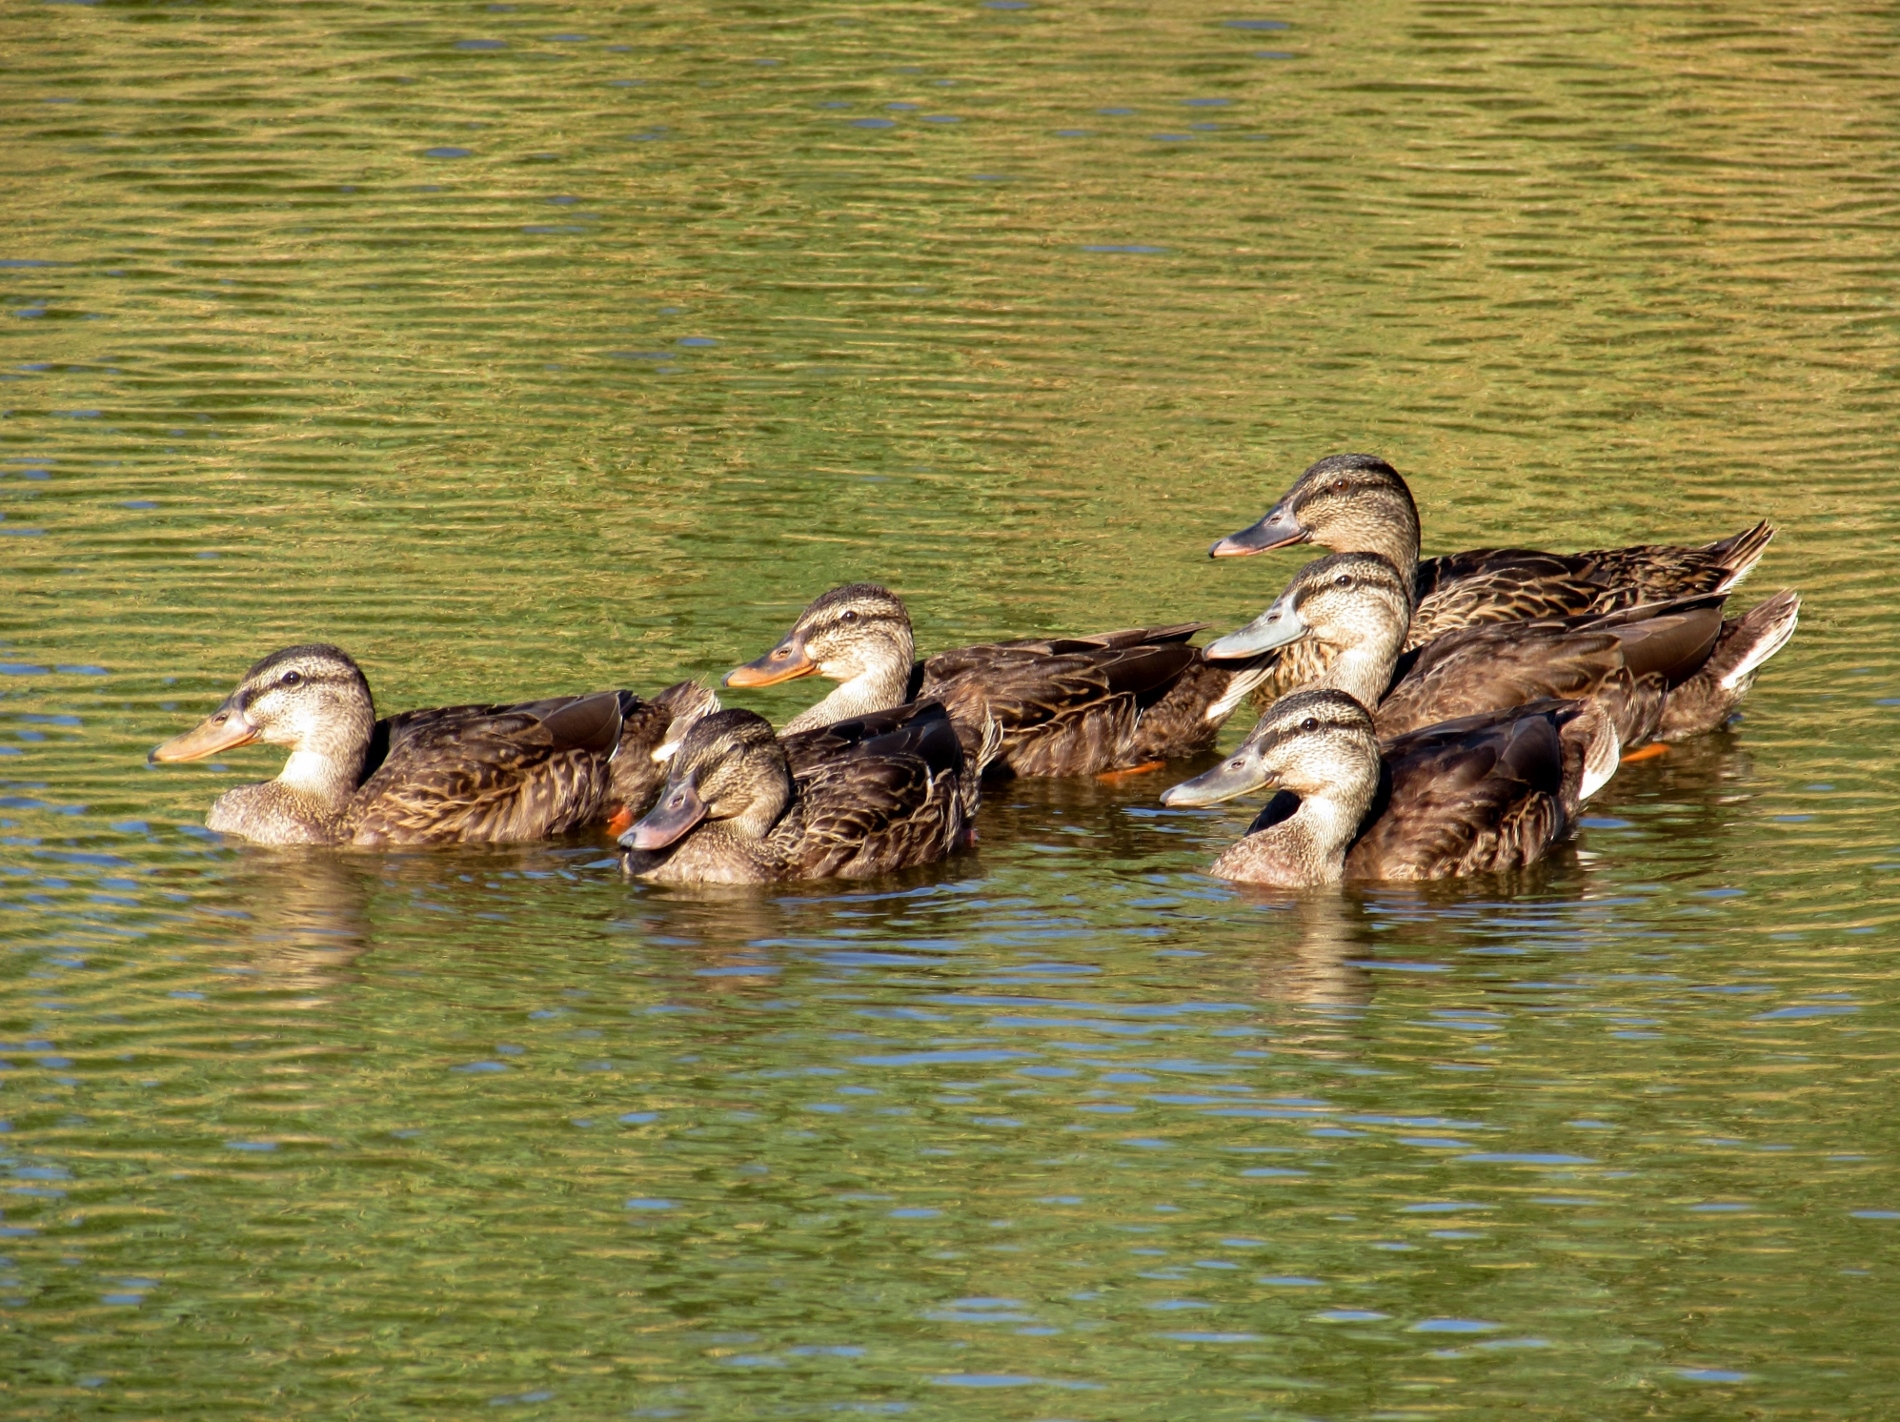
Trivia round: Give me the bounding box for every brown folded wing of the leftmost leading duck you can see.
[346,692,621,844]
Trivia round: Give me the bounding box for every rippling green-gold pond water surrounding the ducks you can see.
[0,0,1900,1422]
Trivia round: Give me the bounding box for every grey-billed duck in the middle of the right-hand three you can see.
[1207,553,1801,749]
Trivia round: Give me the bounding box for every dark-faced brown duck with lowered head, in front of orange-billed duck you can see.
[619,701,994,884]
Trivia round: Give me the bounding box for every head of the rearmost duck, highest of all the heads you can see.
[1207,454,1419,576]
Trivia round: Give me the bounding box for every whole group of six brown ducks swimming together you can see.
[152,454,1799,886]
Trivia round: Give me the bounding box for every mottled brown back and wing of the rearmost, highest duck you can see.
[1406,523,1775,646]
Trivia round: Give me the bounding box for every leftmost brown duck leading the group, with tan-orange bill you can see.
[150,643,718,846]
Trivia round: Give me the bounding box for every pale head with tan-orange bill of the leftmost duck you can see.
[150,643,376,795]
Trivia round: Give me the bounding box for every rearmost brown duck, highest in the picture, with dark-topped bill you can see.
[1208,454,1775,653]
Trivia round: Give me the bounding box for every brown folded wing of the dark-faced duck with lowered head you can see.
[768,701,973,878]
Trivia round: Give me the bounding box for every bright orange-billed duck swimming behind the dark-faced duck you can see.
[724,584,1264,776]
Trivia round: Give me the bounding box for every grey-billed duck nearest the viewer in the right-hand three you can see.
[1161,688,1621,888]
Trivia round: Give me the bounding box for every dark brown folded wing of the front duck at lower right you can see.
[1345,703,1577,878]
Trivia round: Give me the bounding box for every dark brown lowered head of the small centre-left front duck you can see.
[619,711,792,850]
